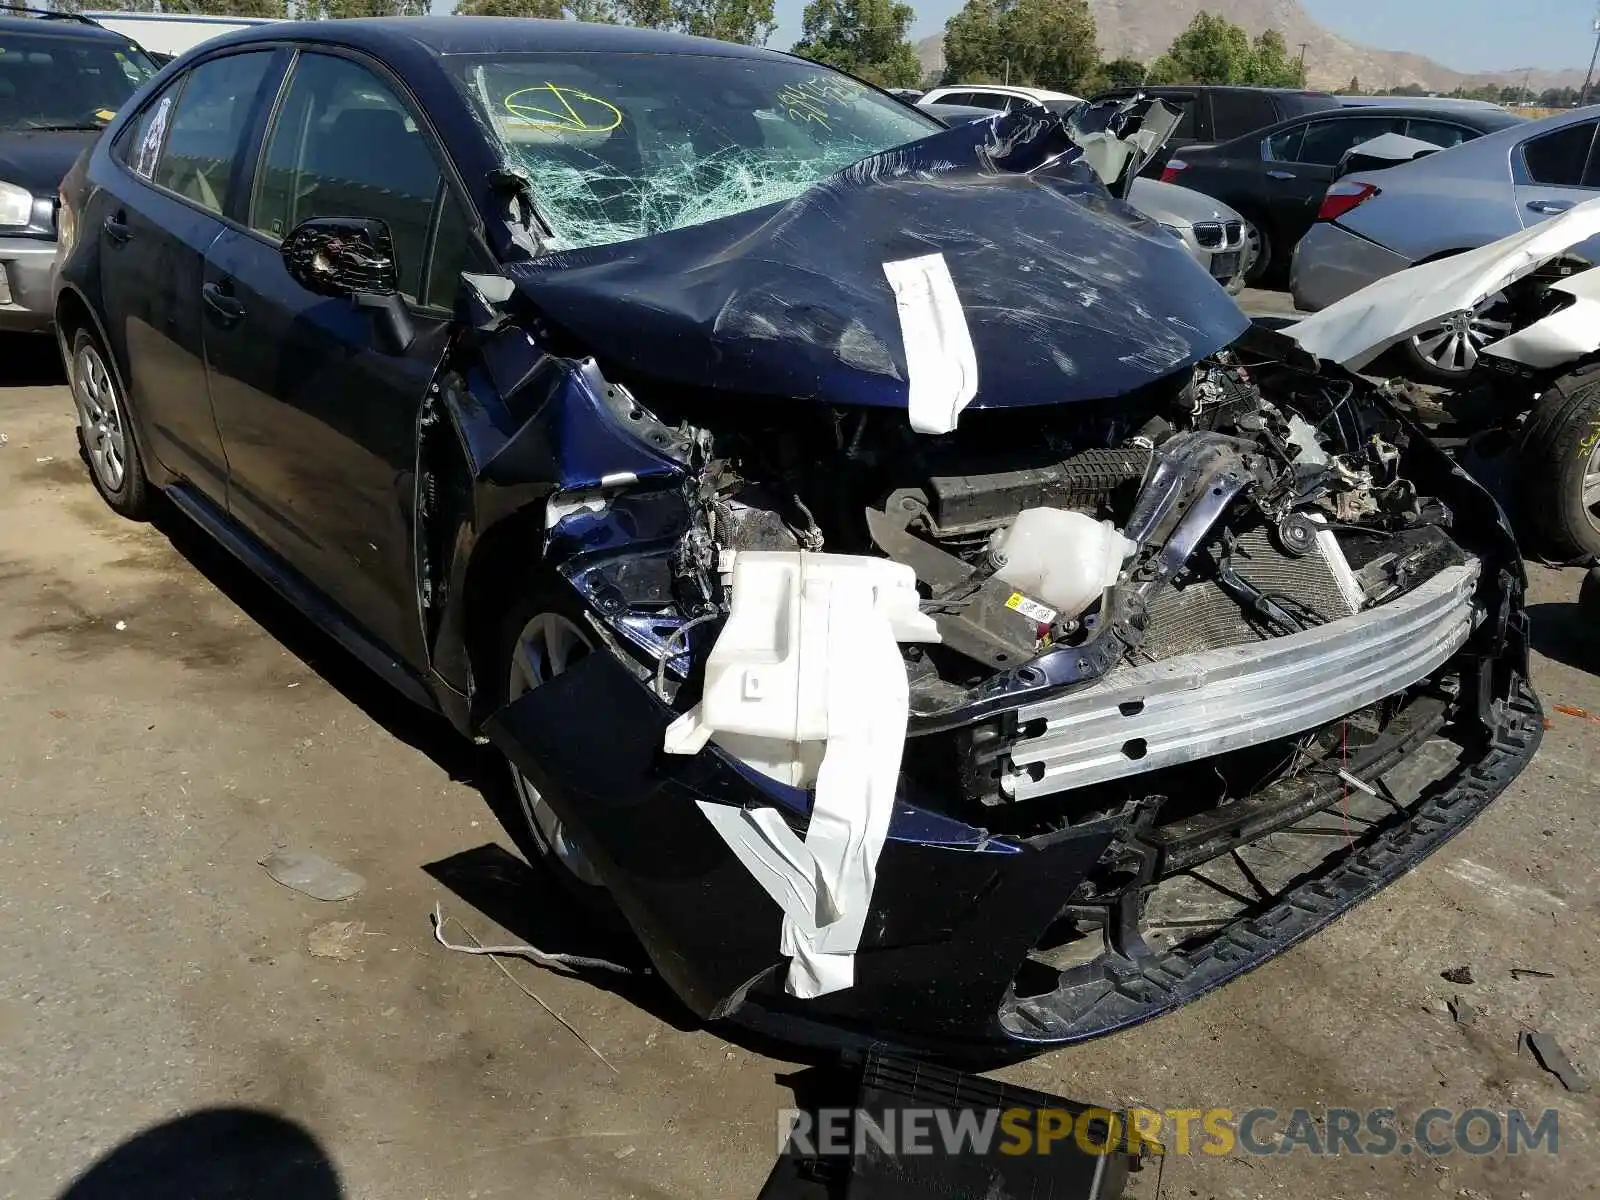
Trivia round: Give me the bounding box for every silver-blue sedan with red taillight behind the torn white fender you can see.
[1290,107,1600,384]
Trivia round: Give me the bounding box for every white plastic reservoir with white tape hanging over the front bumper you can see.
[664,552,939,998]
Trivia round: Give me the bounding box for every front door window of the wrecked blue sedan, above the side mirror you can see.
[250,54,442,299]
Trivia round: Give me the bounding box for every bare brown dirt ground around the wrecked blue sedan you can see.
[0,329,1600,1200]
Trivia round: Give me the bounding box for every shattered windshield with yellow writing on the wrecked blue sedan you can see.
[446,53,942,250]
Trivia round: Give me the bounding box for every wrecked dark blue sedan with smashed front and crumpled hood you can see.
[54,18,1542,1054]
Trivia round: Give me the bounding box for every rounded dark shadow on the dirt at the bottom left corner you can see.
[56,1107,344,1200]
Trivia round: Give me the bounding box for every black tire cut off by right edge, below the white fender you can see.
[1517,363,1600,563]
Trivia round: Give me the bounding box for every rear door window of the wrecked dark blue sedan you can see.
[150,50,274,213]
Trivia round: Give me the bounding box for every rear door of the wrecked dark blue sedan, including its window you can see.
[96,50,277,504]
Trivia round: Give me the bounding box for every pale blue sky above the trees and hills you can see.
[770,0,1597,70]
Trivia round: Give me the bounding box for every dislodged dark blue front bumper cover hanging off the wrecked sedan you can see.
[488,598,1542,1059]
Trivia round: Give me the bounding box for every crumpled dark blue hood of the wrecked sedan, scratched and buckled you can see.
[506,110,1248,408]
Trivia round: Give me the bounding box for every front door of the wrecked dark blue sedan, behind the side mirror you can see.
[202,51,464,667]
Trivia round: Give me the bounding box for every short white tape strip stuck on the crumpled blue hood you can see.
[883,254,978,434]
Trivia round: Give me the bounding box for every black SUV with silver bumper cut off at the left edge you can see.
[0,5,155,333]
